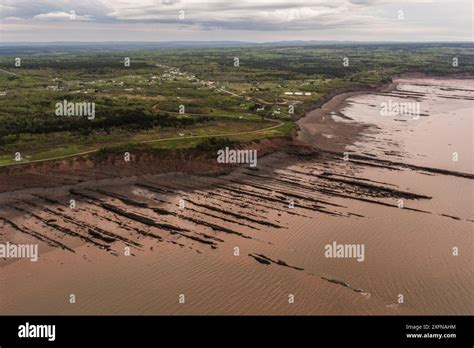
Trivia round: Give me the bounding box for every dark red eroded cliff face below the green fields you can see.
[0,138,292,192]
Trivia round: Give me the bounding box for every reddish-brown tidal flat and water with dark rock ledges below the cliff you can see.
[0,80,474,315]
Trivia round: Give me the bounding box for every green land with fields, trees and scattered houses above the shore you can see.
[0,44,474,165]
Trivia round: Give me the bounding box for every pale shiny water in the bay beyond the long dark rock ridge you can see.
[342,79,474,173]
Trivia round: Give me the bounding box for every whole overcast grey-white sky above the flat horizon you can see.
[0,0,474,42]
